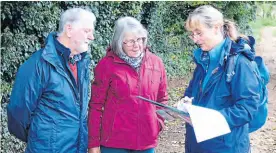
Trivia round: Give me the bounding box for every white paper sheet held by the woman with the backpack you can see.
[184,104,231,142]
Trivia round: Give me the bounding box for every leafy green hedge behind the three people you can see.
[0,1,257,153]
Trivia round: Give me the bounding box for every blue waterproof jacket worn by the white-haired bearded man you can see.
[7,33,90,153]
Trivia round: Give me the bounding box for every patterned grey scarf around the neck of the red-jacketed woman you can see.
[118,52,145,70]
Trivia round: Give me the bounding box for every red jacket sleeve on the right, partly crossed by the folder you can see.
[157,59,169,130]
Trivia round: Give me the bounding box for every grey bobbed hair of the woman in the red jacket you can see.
[111,17,148,55]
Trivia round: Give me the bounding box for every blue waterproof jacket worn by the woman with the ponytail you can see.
[184,38,261,153]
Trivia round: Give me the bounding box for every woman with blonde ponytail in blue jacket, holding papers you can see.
[184,5,260,153]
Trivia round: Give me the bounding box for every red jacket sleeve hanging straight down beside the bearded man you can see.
[88,59,109,148]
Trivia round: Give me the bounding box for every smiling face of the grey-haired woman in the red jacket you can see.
[123,32,144,57]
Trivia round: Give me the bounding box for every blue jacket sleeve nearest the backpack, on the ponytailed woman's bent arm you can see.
[220,56,260,128]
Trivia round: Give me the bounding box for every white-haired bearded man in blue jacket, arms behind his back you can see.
[7,8,96,153]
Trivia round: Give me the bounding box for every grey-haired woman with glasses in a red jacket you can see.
[88,17,168,153]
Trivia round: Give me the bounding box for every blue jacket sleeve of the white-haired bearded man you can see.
[7,60,42,142]
